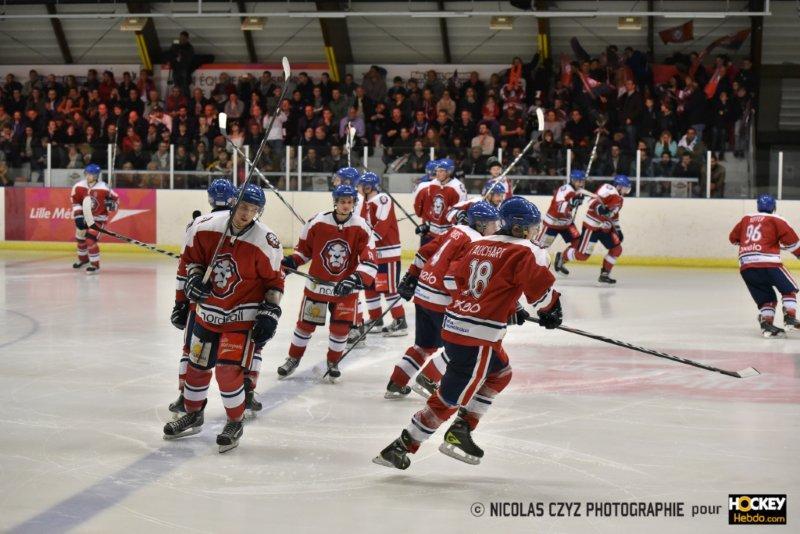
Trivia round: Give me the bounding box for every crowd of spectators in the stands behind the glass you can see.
[0,37,758,196]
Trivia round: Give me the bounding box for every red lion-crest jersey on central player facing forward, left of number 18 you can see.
[292,211,378,302]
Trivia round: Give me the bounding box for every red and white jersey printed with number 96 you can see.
[728,213,800,271]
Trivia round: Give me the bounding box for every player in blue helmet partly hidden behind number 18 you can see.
[384,201,500,399]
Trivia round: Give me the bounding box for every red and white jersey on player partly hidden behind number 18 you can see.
[408,224,483,313]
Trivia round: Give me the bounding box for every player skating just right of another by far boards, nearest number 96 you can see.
[554,174,631,284]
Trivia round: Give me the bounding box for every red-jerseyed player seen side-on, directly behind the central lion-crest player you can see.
[358,172,408,337]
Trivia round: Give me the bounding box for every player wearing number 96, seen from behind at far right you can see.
[729,195,800,338]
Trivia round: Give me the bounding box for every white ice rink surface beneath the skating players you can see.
[0,252,800,533]
